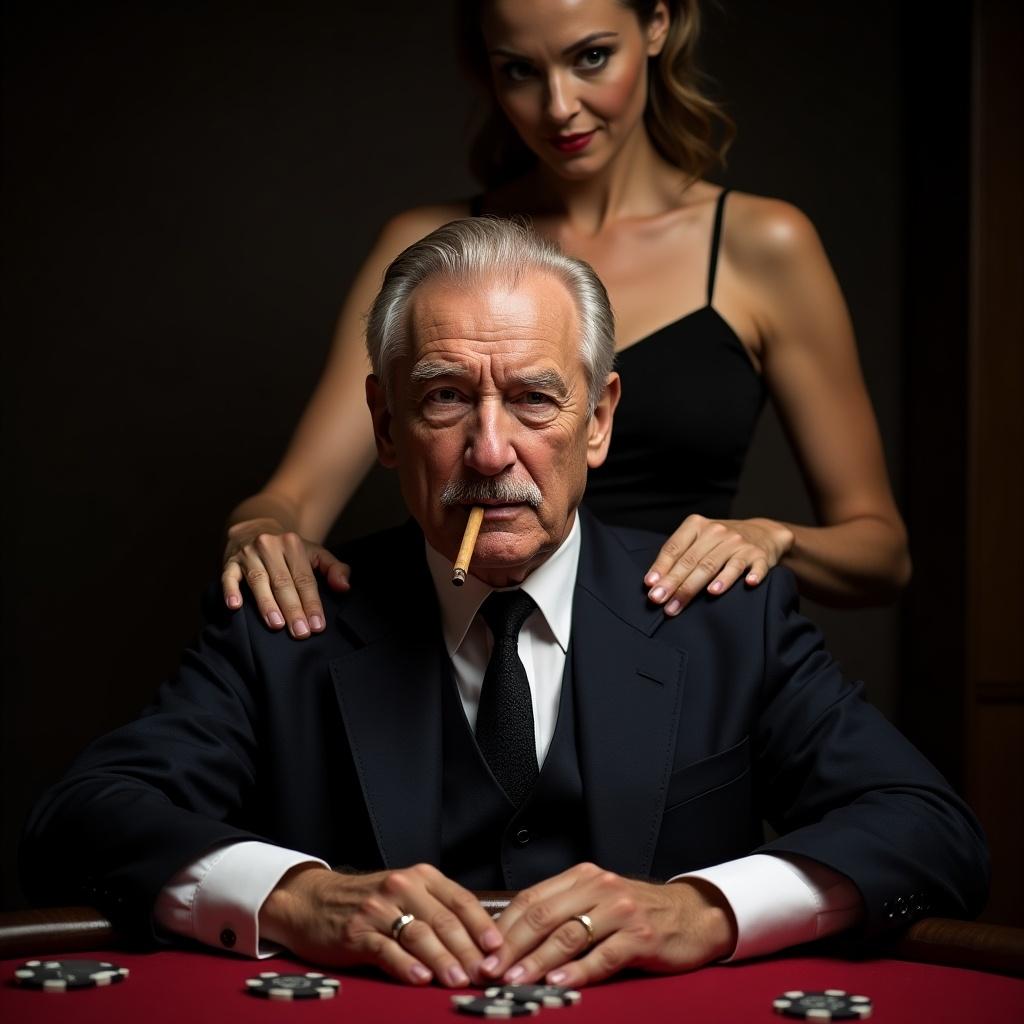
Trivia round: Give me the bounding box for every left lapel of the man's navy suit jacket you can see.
[331,529,444,868]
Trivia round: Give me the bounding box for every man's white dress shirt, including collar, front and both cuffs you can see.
[154,516,863,959]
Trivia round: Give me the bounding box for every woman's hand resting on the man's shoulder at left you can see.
[220,519,349,640]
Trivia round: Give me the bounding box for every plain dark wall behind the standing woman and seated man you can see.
[0,0,969,906]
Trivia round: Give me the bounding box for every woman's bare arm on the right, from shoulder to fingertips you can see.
[646,195,910,613]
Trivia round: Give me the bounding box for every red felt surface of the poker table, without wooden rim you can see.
[0,937,1024,1024]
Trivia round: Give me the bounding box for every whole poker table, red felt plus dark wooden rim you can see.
[0,909,1024,1024]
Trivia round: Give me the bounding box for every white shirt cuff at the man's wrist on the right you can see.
[669,853,863,962]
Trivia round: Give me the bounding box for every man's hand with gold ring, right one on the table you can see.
[483,864,736,987]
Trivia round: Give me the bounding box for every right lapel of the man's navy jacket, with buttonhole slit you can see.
[572,516,686,876]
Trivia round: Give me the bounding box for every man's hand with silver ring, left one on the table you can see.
[259,864,502,988]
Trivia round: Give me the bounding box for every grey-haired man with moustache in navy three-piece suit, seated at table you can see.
[24,220,986,986]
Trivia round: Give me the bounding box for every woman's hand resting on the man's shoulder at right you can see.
[644,515,793,615]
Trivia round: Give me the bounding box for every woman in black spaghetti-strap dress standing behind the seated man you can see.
[223,0,909,638]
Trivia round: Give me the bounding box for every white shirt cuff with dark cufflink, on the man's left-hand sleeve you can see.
[153,841,328,958]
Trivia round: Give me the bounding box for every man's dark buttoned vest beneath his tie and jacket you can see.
[440,645,589,890]
